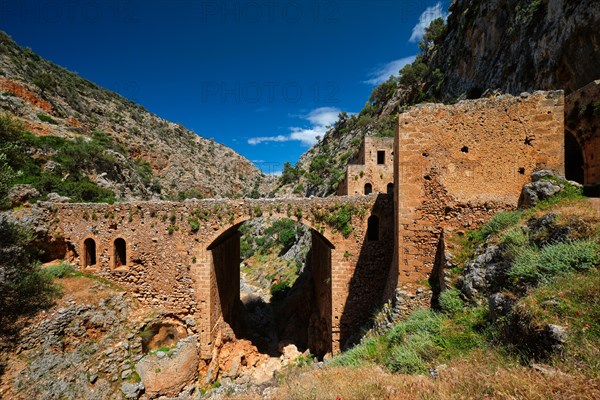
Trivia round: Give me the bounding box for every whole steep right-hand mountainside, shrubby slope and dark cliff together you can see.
[273,0,600,196]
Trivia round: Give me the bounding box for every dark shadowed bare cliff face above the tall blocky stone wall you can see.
[432,0,600,98]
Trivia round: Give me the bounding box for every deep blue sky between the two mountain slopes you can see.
[0,0,448,172]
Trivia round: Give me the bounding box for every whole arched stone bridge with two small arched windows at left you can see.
[48,194,397,359]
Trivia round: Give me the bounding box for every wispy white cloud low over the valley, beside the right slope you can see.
[248,107,341,146]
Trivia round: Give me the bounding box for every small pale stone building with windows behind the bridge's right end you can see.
[337,136,394,196]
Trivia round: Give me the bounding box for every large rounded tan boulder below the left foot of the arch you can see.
[135,336,199,398]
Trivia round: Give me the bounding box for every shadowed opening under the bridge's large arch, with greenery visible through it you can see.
[208,217,333,356]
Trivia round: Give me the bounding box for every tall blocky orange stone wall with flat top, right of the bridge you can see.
[394,92,564,289]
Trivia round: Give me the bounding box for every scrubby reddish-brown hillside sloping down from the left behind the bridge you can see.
[0,32,263,200]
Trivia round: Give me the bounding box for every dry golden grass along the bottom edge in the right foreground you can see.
[258,351,600,400]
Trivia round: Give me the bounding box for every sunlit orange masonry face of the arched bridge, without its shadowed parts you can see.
[46,196,393,358]
